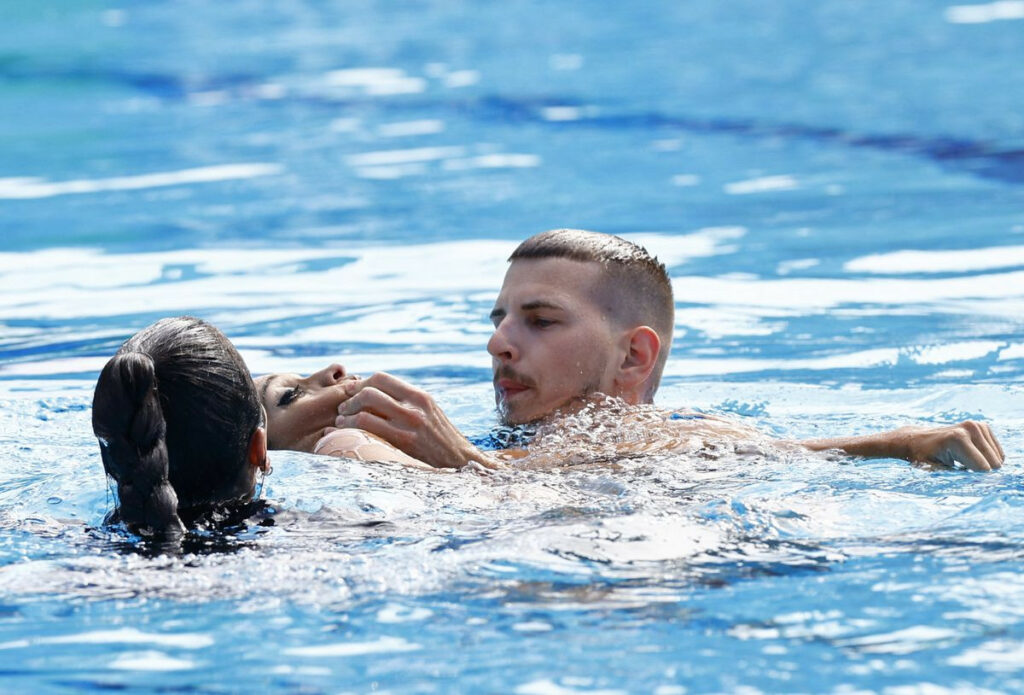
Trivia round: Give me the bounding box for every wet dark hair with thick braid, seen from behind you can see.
[92,316,261,539]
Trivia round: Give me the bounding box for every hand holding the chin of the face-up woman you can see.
[335,372,498,468]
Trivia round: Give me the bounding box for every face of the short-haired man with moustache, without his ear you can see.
[487,258,626,424]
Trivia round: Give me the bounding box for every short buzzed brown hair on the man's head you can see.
[509,229,676,400]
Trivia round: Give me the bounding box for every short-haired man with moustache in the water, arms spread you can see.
[336,229,1005,471]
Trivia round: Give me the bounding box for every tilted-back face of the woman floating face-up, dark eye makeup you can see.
[256,364,355,451]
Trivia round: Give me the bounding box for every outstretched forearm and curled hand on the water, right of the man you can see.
[800,420,1006,471]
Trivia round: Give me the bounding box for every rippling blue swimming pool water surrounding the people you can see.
[0,0,1024,695]
